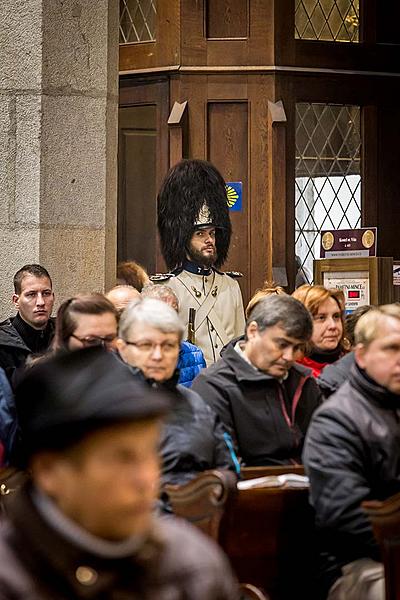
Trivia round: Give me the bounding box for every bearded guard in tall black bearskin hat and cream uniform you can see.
[150,160,245,365]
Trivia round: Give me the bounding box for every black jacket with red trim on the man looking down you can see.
[192,344,321,466]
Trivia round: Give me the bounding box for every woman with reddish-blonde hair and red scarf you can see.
[292,284,346,377]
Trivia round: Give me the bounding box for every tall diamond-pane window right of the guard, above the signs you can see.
[295,102,361,283]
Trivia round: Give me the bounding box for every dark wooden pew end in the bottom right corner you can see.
[362,493,400,600]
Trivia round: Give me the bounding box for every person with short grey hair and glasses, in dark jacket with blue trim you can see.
[117,298,237,494]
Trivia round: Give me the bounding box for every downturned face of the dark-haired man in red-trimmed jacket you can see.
[245,321,304,379]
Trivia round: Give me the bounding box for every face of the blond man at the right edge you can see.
[355,317,400,395]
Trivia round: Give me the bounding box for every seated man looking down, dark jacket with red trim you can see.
[192,294,320,466]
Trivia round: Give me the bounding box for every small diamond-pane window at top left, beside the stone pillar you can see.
[119,0,157,44]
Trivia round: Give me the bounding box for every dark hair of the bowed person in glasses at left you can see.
[53,293,118,350]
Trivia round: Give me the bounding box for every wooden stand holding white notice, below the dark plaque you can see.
[314,257,393,313]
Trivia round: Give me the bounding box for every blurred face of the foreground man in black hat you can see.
[32,420,160,541]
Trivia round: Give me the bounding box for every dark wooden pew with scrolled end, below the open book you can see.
[166,467,316,600]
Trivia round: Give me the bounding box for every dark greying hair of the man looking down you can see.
[246,294,313,342]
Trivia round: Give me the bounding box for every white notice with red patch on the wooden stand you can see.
[324,271,369,313]
